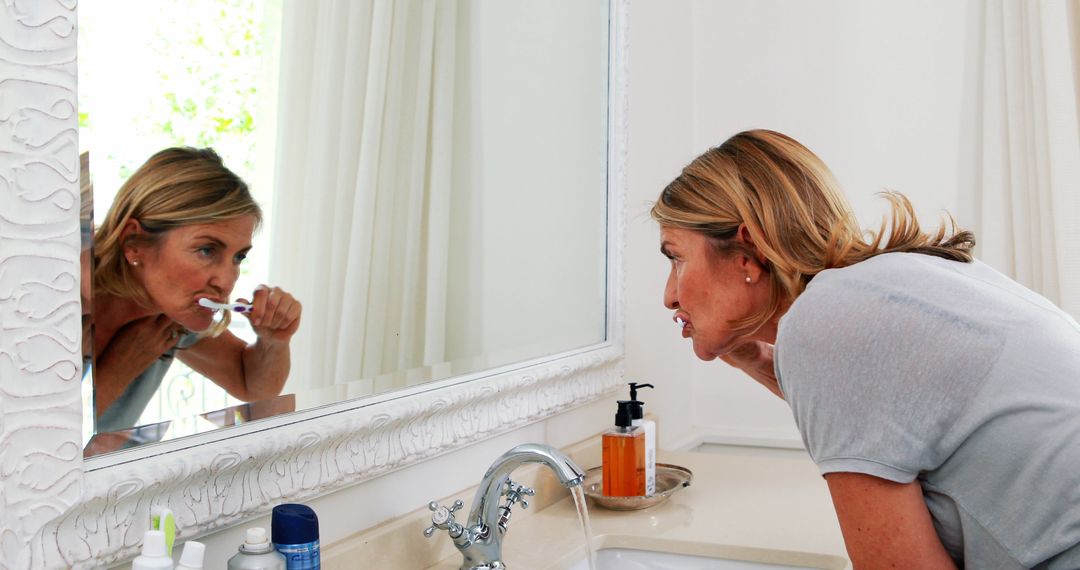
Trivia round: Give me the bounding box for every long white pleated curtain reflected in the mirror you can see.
[270,0,457,392]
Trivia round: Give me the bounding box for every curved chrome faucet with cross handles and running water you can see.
[423,444,585,570]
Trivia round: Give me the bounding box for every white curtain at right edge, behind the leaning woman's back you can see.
[959,0,1080,318]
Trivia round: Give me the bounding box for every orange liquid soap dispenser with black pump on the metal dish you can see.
[600,399,645,497]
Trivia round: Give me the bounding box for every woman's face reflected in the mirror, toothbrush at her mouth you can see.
[135,216,256,330]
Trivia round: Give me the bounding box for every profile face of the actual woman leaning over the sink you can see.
[660,228,760,361]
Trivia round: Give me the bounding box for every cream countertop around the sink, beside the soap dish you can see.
[431,451,850,570]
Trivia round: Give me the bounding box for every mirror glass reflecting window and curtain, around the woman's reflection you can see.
[78,0,611,456]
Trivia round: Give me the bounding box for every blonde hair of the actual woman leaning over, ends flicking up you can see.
[651,130,975,336]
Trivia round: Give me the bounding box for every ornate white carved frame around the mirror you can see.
[0,0,629,569]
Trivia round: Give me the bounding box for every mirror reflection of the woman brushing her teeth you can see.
[93,148,301,433]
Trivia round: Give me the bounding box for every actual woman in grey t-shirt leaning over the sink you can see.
[652,131,1080,569]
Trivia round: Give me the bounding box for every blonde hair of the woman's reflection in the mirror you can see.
[94,147,262,335]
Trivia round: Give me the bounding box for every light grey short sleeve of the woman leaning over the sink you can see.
[775,273,1003,483]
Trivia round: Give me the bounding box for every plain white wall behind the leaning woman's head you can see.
[626,0,970,447]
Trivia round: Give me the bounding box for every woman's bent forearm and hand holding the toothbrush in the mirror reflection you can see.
[176,287,301,402]
